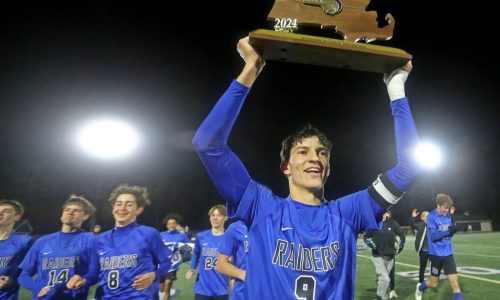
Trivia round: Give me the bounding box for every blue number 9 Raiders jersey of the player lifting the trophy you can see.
[193,81,421,300]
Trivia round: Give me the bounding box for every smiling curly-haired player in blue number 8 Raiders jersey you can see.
[95,184,170,300]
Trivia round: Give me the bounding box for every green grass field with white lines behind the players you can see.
[20,232,500,300]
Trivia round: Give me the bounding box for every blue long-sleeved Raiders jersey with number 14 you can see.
[19,231,98,299]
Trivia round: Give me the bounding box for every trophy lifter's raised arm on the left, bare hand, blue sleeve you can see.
[193,37,265,214]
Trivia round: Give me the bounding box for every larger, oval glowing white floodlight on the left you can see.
[77,119,139,160]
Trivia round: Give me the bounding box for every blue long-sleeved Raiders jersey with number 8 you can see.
[95,222,170,300]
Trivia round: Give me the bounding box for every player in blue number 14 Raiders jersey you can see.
[19,195,98,299]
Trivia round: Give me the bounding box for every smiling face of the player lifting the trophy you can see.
[281,136,330,193]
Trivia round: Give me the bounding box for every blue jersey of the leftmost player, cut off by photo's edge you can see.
[0,233,33,300]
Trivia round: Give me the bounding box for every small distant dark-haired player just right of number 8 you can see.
[160,214,190,300]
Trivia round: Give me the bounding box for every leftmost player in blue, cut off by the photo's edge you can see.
[0,199,33,300]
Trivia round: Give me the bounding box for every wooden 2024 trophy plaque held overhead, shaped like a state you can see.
[250,0,412,73]
